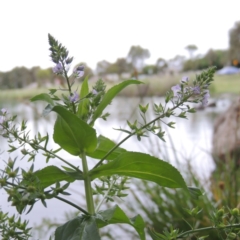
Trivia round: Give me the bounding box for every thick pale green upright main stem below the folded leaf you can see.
[80,152,95,215]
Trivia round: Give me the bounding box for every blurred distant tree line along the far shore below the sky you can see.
[0,22,240,89]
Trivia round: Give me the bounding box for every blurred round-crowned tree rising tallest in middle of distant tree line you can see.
[127,46,150,71]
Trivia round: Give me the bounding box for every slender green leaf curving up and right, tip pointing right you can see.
[90,80,142,125]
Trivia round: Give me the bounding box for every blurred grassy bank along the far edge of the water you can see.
[0,74,240,101]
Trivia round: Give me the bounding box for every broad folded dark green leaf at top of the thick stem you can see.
[52,106,97,156]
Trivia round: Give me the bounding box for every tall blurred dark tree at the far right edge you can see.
[229,22,240,66]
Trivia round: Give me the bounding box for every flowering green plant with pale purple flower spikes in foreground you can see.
[0,34,238,240]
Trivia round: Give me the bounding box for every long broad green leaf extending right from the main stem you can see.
[89,152,187,189]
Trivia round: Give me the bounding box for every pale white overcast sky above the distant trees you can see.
[0,0,240,72]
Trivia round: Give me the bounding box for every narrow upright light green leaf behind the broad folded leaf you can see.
[77,77,89,119]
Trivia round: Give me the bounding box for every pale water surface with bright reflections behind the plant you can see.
[0,97,230,239]
